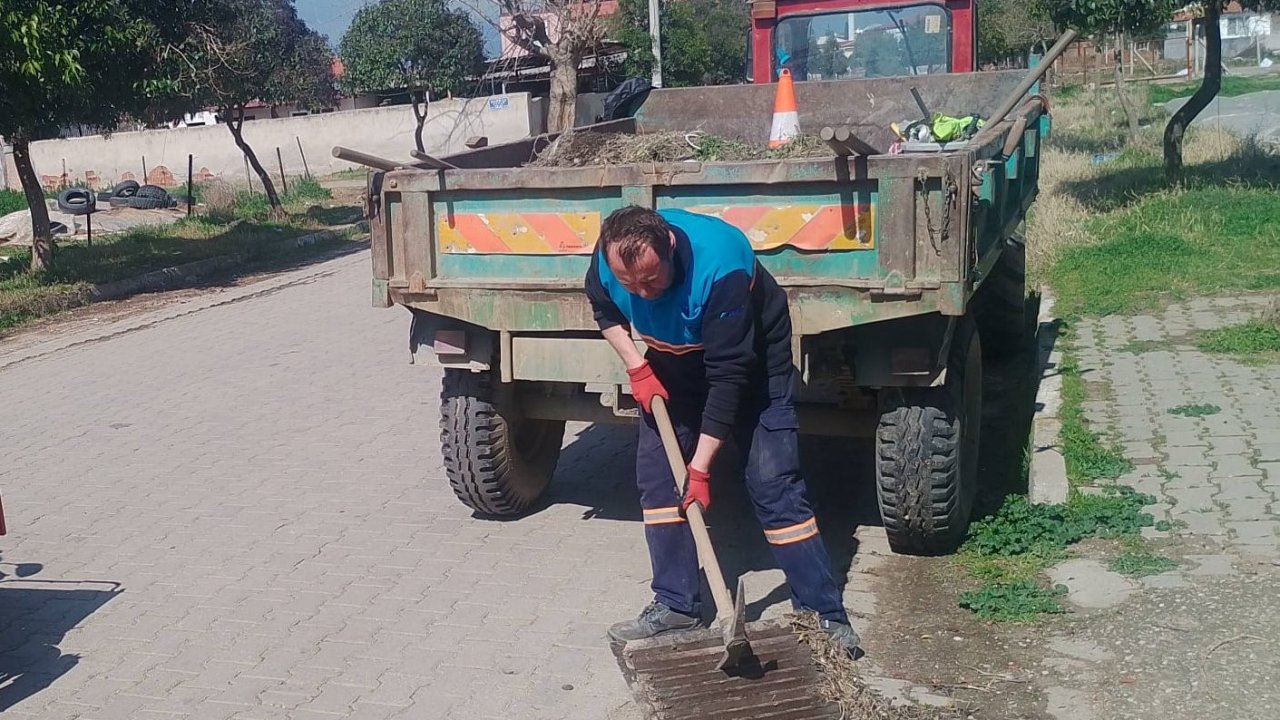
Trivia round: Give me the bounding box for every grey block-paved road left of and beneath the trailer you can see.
[0,255,883,720]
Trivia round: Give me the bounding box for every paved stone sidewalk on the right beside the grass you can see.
[1078,296,1280,562]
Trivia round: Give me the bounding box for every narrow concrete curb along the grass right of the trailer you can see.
[1028,287,1069,505]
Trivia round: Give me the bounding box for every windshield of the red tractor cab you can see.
[773,4,951,79]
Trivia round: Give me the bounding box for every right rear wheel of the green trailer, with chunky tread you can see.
[876,316,982,555]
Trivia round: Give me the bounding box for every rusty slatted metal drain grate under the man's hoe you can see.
[613,620,840,720]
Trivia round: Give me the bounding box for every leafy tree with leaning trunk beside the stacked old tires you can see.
[173,0,337,215]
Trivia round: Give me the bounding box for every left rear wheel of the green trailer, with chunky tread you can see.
[440,369,564,518]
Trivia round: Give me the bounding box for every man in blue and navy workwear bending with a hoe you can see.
[586,206,859,653]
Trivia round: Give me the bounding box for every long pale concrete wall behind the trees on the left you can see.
[8,94,547,187]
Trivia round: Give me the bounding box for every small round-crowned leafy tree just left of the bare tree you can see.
[338,0,484,151]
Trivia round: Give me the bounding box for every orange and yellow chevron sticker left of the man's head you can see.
[435,213,600,255]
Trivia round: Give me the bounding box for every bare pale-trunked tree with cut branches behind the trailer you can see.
[466,0,609,132]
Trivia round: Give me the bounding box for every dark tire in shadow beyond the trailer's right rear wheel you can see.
[974,233,1029,360]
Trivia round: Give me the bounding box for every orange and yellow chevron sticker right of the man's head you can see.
[689,205,876,250]
